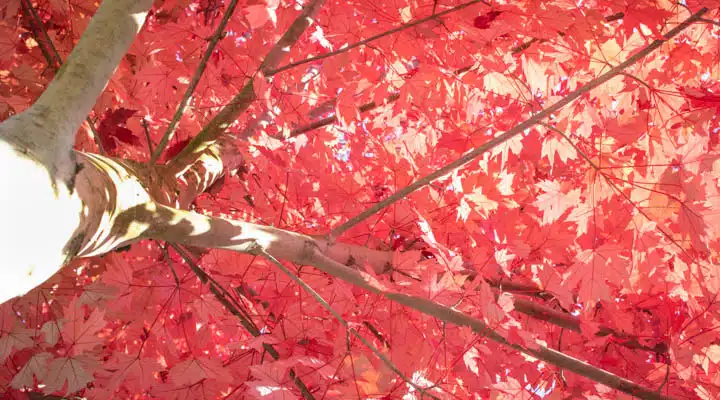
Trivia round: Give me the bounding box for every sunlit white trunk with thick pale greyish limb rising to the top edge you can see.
[0,0,152,303]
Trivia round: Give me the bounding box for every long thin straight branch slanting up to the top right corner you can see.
[330,8,708,238]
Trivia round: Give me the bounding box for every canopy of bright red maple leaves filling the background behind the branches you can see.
[0,0,720,399]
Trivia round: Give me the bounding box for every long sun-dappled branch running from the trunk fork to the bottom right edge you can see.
[142,205,667,399]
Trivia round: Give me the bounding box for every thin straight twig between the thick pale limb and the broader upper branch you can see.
[148,0,243,165]
